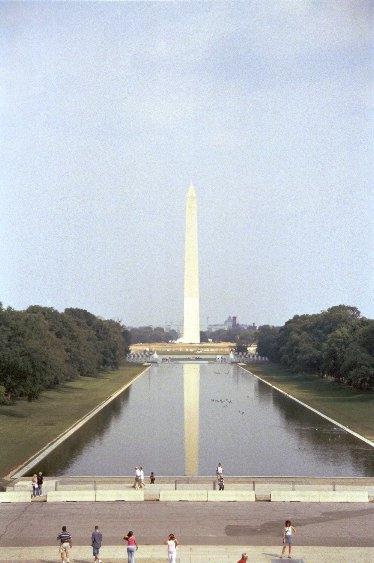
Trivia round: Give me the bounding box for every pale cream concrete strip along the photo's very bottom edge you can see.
[0,545,374,563]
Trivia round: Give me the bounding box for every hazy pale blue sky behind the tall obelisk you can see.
[0,0,374,326]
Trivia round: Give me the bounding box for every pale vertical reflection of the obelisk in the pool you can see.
[183,364,200,475]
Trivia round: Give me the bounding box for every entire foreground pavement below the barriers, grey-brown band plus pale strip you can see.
[0,502,374,563]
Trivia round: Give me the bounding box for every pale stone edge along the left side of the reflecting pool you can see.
[4,365,151,479]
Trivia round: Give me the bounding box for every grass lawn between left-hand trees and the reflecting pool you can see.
[0,365,144,476]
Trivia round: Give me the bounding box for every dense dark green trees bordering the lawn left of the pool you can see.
[0,304,130,403]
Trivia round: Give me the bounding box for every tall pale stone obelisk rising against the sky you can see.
[182,184,200,344]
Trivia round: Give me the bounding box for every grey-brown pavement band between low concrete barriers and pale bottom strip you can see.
[0,502,374,548]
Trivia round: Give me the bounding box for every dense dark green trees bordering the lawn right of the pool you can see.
[257,305,374,390]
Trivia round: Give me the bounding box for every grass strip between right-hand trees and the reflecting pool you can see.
[243,364,374,441]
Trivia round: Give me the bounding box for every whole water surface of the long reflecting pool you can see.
[32,362,374,477]
